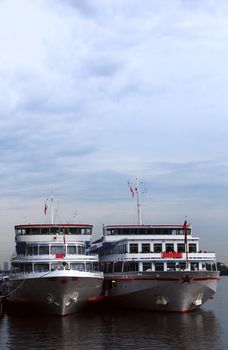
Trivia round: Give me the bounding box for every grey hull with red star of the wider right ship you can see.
[103,271,219,312]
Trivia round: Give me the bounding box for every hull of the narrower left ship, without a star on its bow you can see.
[7,271,103,316]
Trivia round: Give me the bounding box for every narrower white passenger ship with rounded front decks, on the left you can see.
[7,212,103,316]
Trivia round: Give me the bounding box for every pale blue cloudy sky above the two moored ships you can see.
[0,0,228,263]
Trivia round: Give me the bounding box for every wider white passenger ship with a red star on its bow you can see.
[92,178,219,312]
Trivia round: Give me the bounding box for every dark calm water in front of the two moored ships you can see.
[0,277,228,350]
